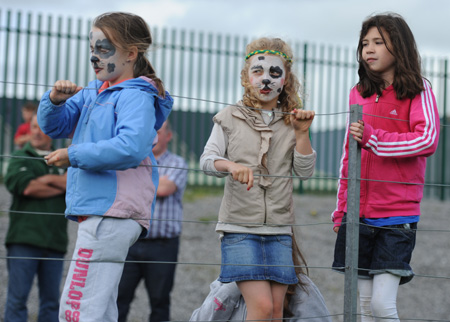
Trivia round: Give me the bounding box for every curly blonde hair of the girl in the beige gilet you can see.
[241,37,303,124]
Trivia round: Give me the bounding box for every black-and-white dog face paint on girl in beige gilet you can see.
[248,54,286,103]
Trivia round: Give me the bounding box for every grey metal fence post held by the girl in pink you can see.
[344,105,362,322]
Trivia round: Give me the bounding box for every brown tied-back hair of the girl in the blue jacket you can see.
[93,12,165,97]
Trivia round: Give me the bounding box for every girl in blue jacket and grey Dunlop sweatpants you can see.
[38,12,173,322]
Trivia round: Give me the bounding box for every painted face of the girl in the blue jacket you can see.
[89,27,133,85]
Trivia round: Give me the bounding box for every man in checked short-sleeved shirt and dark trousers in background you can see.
[117,121,187,322]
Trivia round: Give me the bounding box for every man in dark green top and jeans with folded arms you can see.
[4,114,68,322]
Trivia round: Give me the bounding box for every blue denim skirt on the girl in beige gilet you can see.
[219,233,298,284]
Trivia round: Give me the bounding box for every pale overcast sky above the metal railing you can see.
[0,0,450,57]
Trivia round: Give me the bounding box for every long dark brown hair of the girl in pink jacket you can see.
[357,13,424,100]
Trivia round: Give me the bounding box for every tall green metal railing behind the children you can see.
[0,9,450,200]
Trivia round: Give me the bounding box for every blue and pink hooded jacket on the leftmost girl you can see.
[38,77,173,229]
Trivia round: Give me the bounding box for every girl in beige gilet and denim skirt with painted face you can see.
[200,38,316,321]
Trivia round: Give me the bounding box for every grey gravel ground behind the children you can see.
[0,186,450,322]
